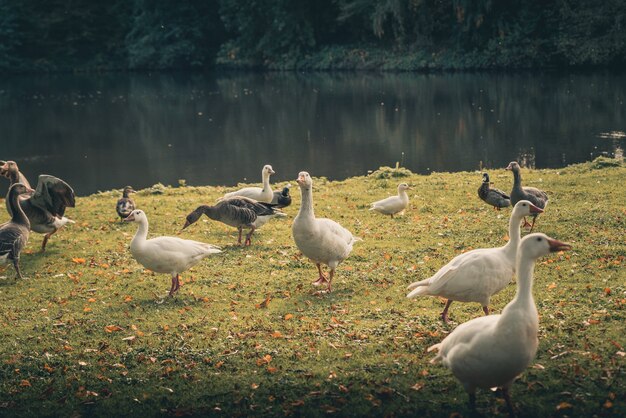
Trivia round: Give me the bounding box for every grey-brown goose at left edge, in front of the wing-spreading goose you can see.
[0,183,34,279]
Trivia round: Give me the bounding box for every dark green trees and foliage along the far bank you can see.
[0,0,626,71]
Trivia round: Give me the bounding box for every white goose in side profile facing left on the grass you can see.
[124,209,222,297]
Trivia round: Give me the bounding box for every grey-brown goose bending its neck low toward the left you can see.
[183,196,287,246]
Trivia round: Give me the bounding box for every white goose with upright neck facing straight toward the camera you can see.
[292,171,362,292]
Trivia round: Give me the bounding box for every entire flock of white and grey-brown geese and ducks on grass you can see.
[0,161,571,412]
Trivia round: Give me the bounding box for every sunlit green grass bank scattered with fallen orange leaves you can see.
[0,161,626,417]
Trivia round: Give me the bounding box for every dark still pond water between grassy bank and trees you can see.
[0,73,626,195]
